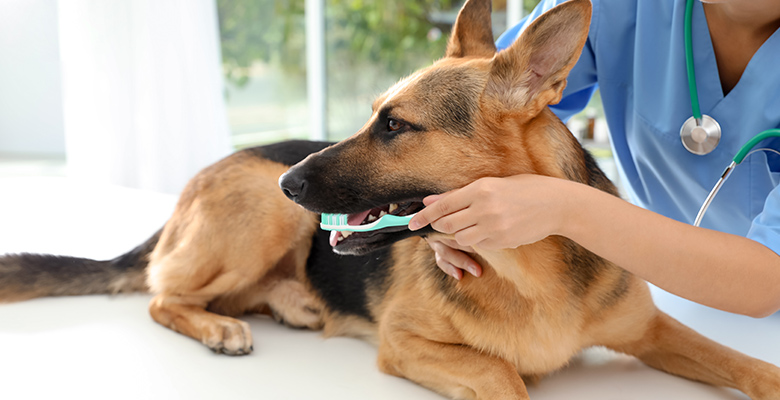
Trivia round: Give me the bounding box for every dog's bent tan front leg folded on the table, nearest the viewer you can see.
[378,330,529,400]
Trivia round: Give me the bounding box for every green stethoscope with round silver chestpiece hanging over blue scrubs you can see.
[680,0,780,226]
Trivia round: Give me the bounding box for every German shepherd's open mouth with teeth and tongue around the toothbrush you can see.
[330,201,425,247]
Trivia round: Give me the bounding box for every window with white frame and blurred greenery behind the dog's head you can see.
[217,0,538,148]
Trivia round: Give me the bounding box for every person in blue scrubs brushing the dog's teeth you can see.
[409,0,780,317]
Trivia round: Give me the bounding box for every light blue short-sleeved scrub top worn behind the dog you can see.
[497,0,780,254]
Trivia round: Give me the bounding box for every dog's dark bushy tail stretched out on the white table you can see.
[0,230,162,303]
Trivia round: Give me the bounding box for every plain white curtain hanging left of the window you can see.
[58,0,230,193]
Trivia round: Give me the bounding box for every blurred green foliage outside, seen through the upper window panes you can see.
[217,0,538,87]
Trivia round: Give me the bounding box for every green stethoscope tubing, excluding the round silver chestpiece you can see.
[684,0,780,226]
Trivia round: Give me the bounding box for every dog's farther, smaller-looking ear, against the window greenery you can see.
[445,0,496,58]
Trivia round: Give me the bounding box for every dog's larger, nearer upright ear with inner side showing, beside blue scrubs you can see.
[485,0,591,116]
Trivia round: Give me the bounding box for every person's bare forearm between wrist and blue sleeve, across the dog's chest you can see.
[559,183,780,316]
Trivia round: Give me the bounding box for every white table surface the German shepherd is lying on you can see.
[0,177,780,400]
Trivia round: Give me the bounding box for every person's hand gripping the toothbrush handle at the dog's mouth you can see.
[409,175,573,250]
